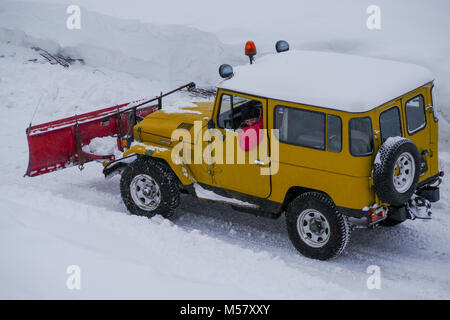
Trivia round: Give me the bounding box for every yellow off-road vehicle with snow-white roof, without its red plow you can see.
[27,41,443,260]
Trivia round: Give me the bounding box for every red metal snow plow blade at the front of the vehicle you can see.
[25,82,195,177]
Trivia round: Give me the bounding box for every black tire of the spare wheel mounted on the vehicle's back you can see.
[373,138,421,206]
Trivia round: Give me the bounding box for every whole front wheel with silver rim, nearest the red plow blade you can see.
[120,158,180,218]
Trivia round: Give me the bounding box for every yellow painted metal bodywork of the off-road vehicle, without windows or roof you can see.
[124,82,438,210]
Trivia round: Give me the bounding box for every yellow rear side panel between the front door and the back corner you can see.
[268,100,375,209]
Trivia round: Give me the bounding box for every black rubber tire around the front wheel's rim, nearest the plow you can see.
[120,158,180,218]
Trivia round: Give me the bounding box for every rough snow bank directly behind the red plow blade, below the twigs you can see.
[0,41,160,124]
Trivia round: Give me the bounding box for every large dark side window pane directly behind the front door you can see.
[274,106,325,150]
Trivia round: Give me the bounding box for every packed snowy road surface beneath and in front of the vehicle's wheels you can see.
[0,150,450,299]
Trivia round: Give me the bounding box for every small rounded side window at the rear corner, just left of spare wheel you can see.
[349,117,373,157]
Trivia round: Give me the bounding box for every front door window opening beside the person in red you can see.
[217,94,263,130]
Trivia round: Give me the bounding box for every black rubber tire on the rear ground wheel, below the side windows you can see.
[286,192,351,260]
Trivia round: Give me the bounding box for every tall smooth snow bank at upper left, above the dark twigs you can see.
[0,1,245,84]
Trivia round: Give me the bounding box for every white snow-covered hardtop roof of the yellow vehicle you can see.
[218,51,433,112]
